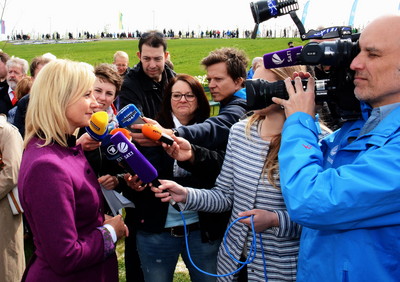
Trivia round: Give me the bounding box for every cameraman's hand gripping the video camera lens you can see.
[272,73,315,117]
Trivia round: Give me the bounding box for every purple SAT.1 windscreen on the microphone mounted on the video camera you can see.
[263,46,303,69]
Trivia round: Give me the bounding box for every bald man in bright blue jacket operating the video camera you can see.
[273,15,400,281]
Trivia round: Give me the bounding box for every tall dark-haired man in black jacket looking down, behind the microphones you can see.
[115,31,175,282]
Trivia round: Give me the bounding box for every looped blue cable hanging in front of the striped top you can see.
[179,212,268,281]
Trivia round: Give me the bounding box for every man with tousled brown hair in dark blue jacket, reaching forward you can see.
[132,47,248,150]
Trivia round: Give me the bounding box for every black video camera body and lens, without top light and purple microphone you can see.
[246,36,360,122]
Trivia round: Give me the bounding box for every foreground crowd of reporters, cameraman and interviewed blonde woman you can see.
[0,15,400,282]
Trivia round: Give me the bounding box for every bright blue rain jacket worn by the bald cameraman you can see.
[279,104,400,282]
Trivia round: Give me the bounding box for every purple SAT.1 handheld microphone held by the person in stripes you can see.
[110,132,180,211]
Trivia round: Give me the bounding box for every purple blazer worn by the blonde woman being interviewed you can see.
[18,138,118,282]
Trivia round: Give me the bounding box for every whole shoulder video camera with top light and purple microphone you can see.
[246,0,360,122]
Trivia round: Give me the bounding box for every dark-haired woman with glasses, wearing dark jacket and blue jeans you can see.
[128,74,228,282]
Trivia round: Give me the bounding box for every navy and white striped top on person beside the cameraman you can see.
[185,120,301,281]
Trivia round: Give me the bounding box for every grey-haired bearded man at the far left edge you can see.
[0,57,29,115]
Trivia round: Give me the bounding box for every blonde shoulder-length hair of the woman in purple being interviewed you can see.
[24,59,95,147]
